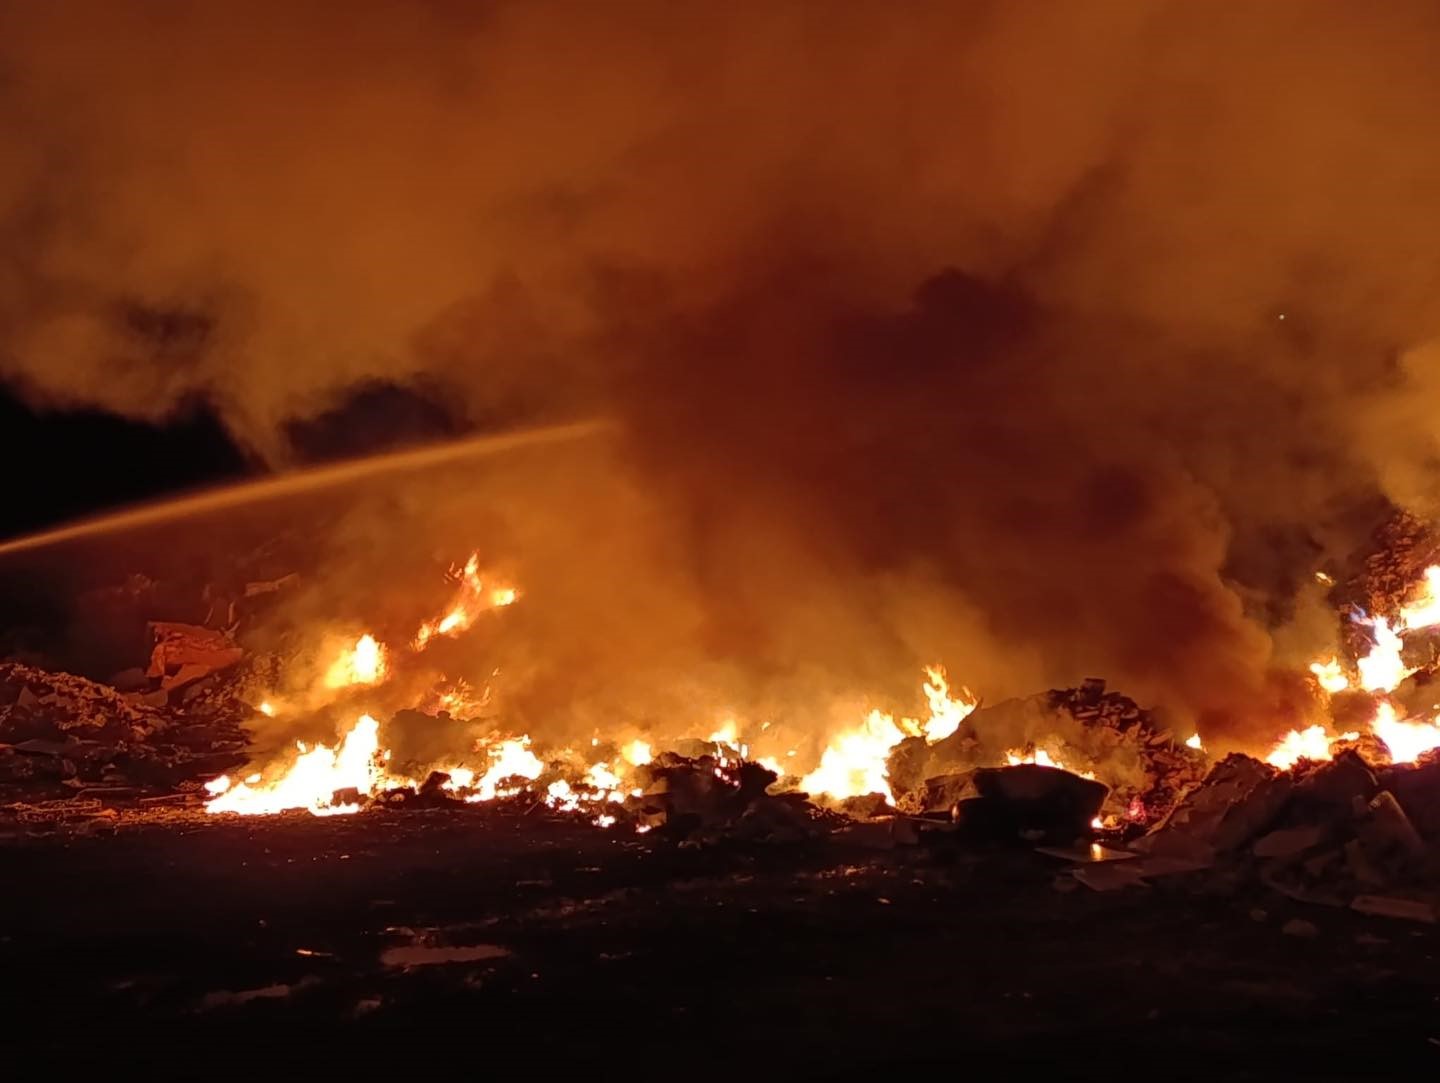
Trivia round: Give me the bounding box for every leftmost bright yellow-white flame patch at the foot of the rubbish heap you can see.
[206,714,384,817]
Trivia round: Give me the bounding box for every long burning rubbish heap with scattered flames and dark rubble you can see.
[8,518,1440,916]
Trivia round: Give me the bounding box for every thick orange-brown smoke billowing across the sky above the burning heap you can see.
[0,0,1440,739]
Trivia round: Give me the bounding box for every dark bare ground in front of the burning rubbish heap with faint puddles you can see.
[0,812,1440,1079]
